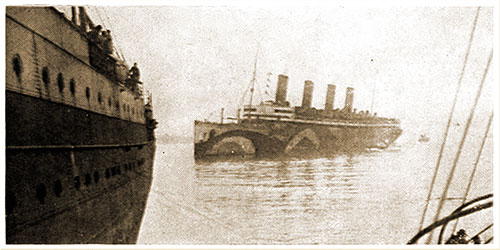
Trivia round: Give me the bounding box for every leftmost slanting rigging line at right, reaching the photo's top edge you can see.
[418,7,480,231]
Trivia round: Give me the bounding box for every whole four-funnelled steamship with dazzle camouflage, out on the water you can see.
[194,75,402,158]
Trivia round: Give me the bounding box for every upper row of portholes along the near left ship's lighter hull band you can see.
[12,54,140,118]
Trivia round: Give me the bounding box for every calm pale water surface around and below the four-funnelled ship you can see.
[138,137,493,245]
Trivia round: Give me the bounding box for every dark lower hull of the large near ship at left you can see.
[6,91,155,244]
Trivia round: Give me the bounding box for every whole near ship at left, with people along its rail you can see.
[5,6,156,244]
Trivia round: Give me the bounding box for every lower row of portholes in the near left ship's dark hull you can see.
[5,158,145,214]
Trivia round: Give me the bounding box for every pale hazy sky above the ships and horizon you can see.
[53,5,492,139]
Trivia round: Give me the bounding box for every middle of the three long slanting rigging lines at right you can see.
[427,49,493,243]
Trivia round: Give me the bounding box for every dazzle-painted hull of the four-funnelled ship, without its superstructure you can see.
[194,119,402,158]
